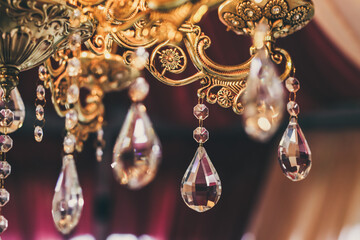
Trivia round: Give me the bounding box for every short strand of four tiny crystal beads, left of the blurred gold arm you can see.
[34,65,49,142]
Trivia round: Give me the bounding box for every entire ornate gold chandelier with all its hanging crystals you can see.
[0,0,314,234]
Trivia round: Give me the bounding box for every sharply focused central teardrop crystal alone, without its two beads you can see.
[181,147,221,212]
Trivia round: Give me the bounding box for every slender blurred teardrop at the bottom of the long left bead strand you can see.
[52,155,84,234]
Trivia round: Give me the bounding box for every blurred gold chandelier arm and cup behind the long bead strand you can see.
[46,51,140,151]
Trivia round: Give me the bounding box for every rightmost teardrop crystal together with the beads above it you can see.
[278,72,312,181]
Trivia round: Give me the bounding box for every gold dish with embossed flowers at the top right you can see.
[218,0,314,38]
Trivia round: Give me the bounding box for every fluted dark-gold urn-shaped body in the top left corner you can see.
[0,0,94,96]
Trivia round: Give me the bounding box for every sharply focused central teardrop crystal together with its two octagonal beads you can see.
[180,101,221,212]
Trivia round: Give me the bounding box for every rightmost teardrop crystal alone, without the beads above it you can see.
[278,117,311,181]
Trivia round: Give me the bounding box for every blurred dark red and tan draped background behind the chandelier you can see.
[3,0,360,240]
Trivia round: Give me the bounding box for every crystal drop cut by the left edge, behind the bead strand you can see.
[0,88,25,133]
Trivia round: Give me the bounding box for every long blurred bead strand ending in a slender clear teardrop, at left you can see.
[52,21,84,234]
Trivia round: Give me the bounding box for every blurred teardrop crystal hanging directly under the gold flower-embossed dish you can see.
[242,49,284,142]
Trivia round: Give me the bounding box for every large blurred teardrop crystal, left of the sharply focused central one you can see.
[111,103,161,189]
